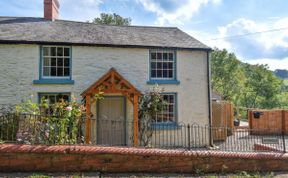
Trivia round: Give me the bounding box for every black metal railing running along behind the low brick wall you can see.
[0,114,288,152]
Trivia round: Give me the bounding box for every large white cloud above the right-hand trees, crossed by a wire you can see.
[212,18,288,59]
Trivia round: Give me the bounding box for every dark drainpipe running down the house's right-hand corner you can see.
[207,50,213,146]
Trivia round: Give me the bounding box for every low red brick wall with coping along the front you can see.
[0,144,288,173]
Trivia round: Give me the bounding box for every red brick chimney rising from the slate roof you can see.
[44,0,60,21]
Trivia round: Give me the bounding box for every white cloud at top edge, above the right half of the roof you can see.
[137,0,221,25]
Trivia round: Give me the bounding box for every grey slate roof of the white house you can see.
[0,17,210,50]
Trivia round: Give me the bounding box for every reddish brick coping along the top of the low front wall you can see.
[0,144,288,160]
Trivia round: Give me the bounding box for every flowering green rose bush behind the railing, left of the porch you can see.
[16,99,85,144]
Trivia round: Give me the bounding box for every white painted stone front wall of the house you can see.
[0,45,208,125]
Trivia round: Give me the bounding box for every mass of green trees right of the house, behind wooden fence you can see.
[211,48,288,115]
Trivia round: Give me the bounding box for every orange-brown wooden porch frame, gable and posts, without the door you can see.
[81,68,141,146]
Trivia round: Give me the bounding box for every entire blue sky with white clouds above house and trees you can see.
[0,0,288,70]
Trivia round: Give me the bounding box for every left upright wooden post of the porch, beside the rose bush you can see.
[85,94,91,144]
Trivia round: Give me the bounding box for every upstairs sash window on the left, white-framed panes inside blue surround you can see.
[42,46,71,78]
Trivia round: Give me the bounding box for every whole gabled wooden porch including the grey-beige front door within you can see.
[81,68,141,146]
